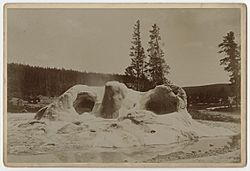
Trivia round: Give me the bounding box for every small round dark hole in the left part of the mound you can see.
[73,93,95,114]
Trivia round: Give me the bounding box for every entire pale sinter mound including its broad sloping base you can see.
[29,82,234,147]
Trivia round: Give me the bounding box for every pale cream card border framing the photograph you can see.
[3,3,247,167]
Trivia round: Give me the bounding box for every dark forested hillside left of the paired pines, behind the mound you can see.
[7,63,137,99]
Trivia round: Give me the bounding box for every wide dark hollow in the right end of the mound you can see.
[146,100,177,115]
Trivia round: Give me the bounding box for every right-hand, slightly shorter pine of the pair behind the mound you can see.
[147,24,170,85]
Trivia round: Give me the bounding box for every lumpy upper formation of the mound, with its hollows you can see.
[35,81,187,120]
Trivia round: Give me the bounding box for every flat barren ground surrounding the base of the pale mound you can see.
[7,113,240,163]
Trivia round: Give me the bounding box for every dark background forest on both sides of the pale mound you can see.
[7,63,232,103]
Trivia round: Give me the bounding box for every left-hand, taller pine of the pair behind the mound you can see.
[125,20,146,90]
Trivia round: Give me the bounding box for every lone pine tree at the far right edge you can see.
[218,31,240,106]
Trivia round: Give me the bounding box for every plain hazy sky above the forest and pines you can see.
[7,8,240,86]
